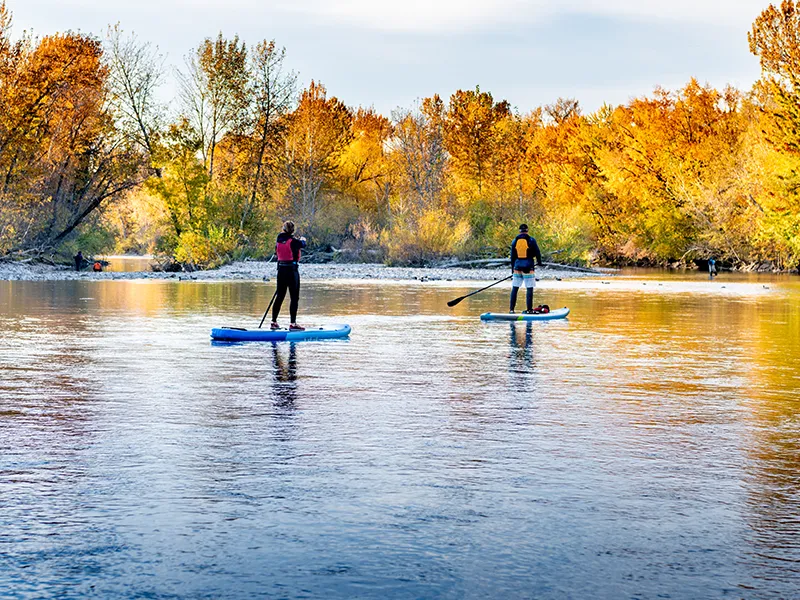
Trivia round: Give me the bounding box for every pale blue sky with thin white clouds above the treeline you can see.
[6,0,777,115]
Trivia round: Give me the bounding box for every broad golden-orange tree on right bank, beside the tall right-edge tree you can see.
[592,80,747,261]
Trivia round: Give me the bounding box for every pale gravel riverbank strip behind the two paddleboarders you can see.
[0,261,614,281]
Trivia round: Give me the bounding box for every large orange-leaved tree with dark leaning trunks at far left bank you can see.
[0,12,143,252]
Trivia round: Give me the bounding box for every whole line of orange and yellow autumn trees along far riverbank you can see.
[0,1,800,268]
